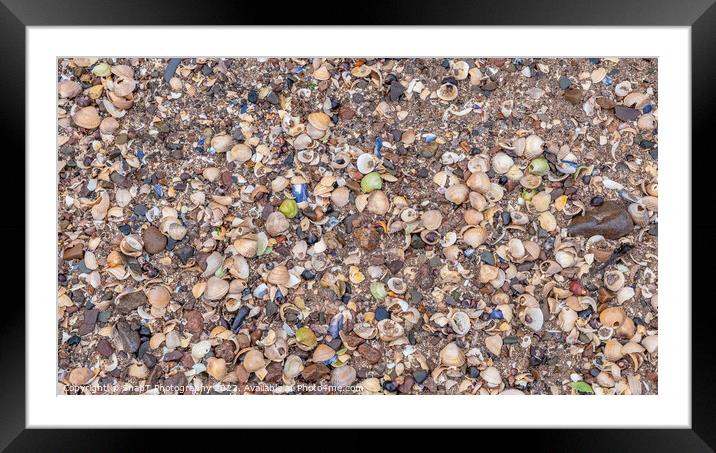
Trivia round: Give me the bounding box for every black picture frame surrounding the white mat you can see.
[0,0,716,452]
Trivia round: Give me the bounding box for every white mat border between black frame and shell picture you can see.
[26,27,691,428]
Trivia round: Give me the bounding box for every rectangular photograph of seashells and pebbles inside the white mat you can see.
[57,56,659,395]
